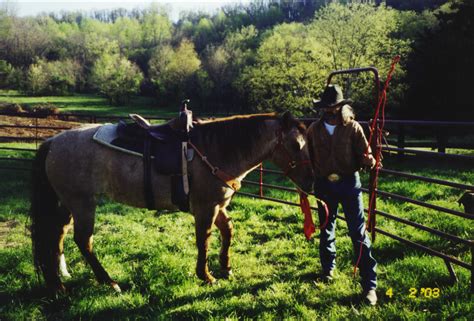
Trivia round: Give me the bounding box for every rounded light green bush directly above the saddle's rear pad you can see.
[91,54,143,104]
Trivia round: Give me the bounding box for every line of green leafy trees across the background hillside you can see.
[0,0,474,120]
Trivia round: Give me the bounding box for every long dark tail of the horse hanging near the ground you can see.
[30,141,70,289]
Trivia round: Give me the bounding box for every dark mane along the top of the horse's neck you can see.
[194,113,305,161]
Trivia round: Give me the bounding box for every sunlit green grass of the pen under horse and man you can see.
[0,144,474,320]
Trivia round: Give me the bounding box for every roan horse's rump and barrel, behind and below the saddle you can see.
[46,125,173,208]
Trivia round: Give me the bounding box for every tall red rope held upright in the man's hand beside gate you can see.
[354,55,400,277]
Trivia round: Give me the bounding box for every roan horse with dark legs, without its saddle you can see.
[31,113,313,292]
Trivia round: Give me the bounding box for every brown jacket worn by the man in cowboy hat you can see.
[307,109,370,177]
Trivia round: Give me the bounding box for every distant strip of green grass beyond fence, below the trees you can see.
[0,90,179,117]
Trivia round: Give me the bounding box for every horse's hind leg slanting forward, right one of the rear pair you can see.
[73,202,121,292]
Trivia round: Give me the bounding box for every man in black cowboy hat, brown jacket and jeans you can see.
[308,85,377,305]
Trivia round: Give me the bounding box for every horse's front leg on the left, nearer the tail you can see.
[194,207,218,284]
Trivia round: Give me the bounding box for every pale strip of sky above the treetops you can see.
[4,0,250,20]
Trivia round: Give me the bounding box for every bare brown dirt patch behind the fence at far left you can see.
[0,115,82,140]
